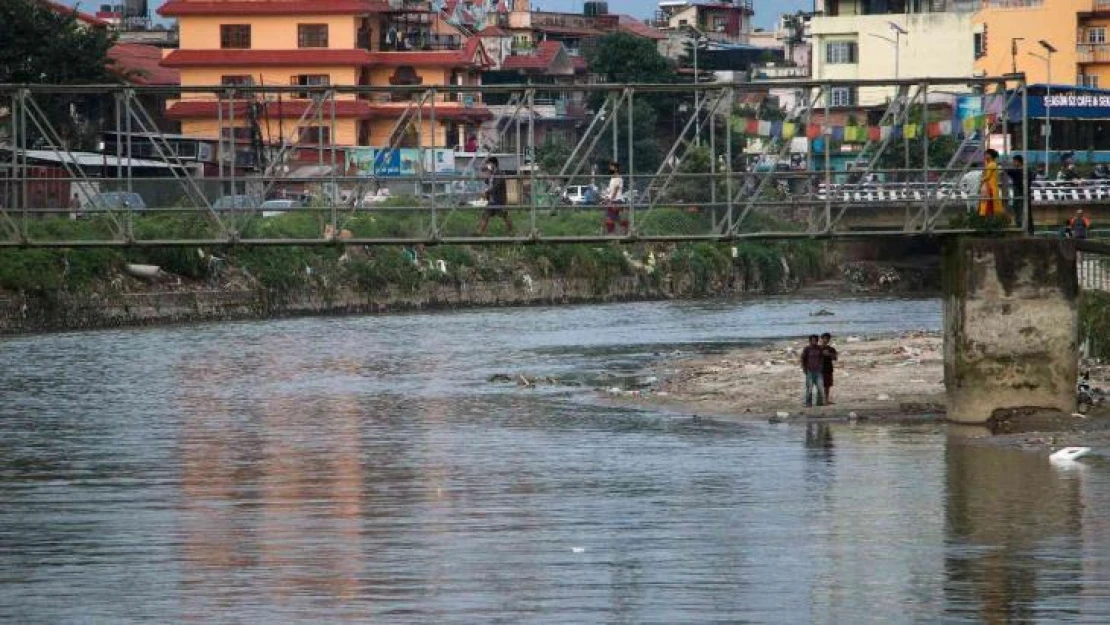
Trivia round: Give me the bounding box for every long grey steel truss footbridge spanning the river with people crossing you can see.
[0,75,1074,248]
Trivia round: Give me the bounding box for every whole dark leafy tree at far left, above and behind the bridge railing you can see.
[0,0,119,147]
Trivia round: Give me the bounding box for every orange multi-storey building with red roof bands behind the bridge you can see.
[159,0,491,152]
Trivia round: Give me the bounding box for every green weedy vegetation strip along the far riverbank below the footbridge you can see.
[0,198,824,298]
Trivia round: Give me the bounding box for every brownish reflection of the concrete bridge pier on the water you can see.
[945,436,1092,623]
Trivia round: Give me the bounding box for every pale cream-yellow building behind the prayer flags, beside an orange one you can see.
[809,0,980,109]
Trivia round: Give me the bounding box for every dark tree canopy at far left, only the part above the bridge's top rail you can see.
[0,0,118,84]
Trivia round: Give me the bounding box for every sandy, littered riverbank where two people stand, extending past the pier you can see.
[609,332,1110,453]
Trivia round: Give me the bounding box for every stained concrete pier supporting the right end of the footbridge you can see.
[942,238,1079,424]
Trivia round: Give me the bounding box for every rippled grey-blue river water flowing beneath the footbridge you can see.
[0,300,1110,624]
